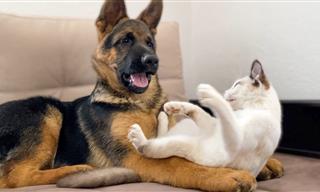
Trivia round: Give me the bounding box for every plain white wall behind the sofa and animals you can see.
[0,0,320,99]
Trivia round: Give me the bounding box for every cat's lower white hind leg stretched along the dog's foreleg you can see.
[128,124,196,160]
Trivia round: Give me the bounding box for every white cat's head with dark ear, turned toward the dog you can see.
[224,60,270,110]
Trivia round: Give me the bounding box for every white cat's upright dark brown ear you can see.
[250,60,270,89]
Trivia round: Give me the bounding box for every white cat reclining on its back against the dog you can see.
[128,61,281,176]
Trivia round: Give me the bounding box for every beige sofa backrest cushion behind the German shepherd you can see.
[0,14,184,103]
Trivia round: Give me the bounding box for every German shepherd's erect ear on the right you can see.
[138,0,163,33]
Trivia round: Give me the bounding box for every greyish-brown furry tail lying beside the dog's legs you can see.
[57,167,141,188]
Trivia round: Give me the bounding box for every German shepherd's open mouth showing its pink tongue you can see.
[122,73,152,93]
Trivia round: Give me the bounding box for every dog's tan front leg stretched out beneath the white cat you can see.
[123,152,256,192]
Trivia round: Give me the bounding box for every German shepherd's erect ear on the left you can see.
[96,0,128,41]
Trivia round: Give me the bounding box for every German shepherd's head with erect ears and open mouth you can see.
[93,0,162,94]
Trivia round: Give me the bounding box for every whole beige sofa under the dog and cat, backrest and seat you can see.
[0,14,320,192]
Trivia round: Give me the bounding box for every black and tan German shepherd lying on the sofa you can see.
[0,0,282,191]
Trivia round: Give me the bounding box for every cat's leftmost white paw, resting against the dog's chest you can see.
[128,124,148,153]
